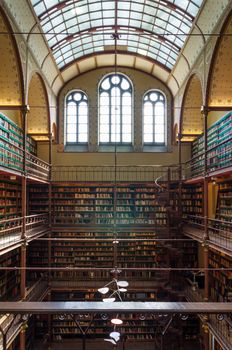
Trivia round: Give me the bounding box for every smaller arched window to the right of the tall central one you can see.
[143,90,166,145]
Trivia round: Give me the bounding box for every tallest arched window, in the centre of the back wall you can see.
[99,73,132,144]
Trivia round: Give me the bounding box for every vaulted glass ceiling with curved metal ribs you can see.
[30,0,203,70]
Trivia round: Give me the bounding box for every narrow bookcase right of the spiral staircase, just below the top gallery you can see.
[181,183,204,223]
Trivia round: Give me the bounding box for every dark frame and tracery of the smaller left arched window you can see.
[64,89,90,147]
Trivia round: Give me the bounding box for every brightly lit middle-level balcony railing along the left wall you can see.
[0,214,48,252]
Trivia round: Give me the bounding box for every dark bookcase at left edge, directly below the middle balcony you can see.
[0,249,20,301]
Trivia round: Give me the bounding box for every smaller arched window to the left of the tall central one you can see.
[66,90,88,144]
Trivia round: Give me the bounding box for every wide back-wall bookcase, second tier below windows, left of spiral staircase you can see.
[51,231,167,286]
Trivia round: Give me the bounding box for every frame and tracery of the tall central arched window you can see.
[97,72,134,147]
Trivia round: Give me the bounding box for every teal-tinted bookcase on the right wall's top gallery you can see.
[191,112,232,176]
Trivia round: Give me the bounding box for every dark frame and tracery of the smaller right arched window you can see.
[142,89,168,148]
